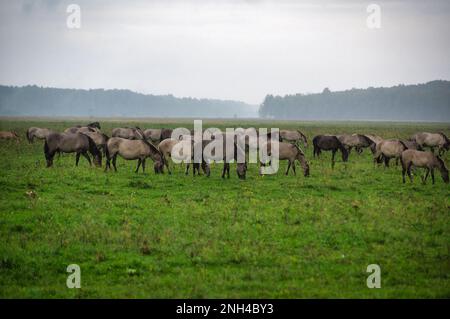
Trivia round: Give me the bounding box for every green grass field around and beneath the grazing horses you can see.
[0,119,450,298]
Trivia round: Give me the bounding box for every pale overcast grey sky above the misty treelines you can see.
[0,0,450,104]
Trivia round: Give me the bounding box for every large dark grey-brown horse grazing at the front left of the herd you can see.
[44,133,102,167]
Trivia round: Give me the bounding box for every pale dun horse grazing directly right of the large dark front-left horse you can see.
[105,137,164,174]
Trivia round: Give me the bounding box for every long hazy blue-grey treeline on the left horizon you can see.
[0,85,258,118]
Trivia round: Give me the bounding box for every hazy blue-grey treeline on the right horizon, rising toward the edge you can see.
[259,81,450,122]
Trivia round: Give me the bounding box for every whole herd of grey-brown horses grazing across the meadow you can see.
[0,122,450,184]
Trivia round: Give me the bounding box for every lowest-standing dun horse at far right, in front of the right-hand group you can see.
[401,150,449,184]
